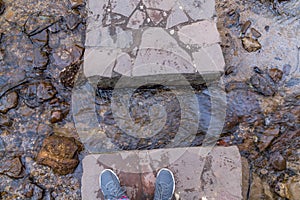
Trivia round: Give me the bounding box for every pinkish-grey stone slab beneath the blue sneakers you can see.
[81,146,242,200]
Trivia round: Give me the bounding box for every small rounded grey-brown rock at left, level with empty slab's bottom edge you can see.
[36,82,57,101]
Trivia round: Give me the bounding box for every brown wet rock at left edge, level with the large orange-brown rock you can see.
[0,157,24,178]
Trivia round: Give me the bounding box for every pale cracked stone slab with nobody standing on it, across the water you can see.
[83,0,225,87]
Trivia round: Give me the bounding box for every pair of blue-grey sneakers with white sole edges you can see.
[99,168,175,200]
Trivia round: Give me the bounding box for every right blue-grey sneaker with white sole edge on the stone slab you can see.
[154,168,175,200]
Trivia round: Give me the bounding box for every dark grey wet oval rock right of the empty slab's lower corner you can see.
[250,74,275,96]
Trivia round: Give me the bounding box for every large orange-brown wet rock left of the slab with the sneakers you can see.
[37,135,80,175]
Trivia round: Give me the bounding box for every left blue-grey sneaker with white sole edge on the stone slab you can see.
[99,169,126,200]
